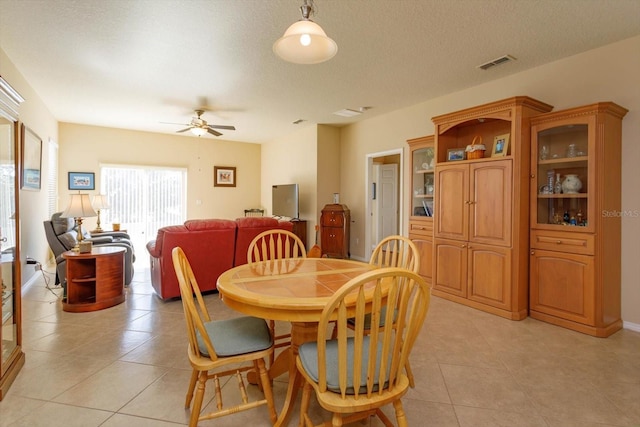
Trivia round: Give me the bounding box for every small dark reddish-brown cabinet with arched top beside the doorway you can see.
[320,204,351,258]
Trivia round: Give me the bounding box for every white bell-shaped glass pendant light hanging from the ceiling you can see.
[273,0,338,64]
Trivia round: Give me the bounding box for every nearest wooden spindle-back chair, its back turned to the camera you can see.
[296,267,430,427]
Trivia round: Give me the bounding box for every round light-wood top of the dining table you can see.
[217,258,376,322]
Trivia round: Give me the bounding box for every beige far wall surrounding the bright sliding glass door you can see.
[58,123,261,224]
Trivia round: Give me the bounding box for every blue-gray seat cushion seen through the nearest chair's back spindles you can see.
[298,336,391,394]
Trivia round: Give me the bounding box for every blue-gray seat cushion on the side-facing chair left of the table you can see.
[196,316,273,357]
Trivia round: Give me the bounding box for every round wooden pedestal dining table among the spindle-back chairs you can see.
[218,258,376,426]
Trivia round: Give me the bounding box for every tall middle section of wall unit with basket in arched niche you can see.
[432,97,553,320]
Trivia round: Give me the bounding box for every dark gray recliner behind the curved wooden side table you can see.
[44,212,136,289]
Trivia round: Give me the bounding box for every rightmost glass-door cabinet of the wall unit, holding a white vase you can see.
[530,102,627,337]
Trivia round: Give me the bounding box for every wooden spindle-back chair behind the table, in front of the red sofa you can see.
[247,229,307,366]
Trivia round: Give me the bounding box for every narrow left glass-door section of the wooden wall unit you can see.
[407,135,436,284]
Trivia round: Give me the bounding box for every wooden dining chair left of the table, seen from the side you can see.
[171,247,277,427]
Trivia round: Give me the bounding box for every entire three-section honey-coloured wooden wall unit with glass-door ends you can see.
[407,96,627,337]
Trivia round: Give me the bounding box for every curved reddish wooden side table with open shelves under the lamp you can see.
[62,246,126,313]
